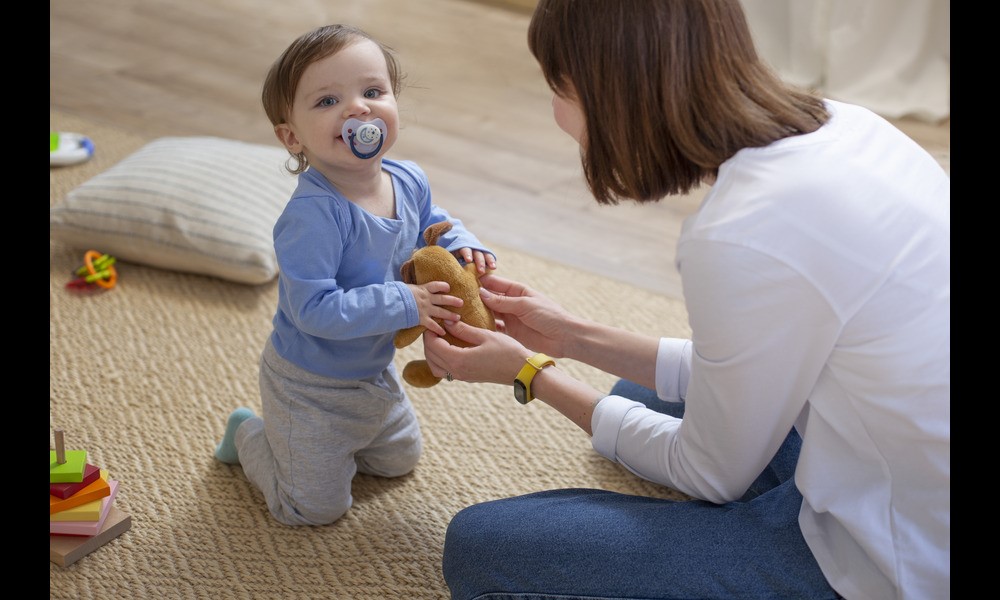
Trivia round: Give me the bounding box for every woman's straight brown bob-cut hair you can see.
[528,0,829,204]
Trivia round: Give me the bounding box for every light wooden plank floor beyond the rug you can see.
[49,0,951,297]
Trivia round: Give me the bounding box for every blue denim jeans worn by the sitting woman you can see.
[443,380,839,600]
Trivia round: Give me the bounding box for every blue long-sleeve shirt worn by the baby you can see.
[271,159,490,379]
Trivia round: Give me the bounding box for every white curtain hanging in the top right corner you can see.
[742,0,951,123]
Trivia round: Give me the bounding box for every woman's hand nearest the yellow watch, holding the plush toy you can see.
[424,322,533,385]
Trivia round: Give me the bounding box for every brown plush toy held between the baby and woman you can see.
[394,221,497,388]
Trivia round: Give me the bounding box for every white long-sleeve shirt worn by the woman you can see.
[592,101,951,600]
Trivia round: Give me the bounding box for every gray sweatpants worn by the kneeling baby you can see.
[236,340,423,525]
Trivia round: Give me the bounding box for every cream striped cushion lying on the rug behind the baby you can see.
[49,137,296,284]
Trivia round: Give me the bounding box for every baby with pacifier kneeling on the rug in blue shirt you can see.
[215,25,496,525]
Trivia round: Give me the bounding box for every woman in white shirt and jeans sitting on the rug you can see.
[424,0,951,599]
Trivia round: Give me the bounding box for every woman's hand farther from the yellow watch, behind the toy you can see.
[479,275,579,358]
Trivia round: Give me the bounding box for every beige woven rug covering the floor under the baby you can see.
[49,112,690,600]
